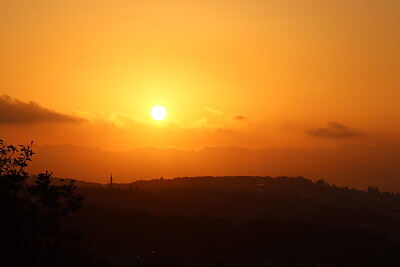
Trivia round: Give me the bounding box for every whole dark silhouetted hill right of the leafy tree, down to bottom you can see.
[67,176,400,266]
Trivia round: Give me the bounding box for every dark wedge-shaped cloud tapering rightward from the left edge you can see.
[0,95,85,124]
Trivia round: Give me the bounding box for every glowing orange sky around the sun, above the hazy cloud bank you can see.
[0,0,400,188]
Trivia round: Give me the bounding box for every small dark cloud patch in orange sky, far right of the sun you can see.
[307,122,362,139]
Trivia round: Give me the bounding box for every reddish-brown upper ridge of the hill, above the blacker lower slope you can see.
[80,176,400,237]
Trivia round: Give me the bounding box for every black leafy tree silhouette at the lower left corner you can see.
[0,140,83,263]
